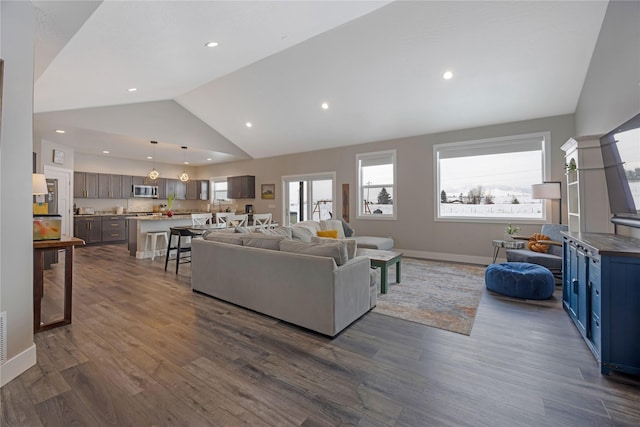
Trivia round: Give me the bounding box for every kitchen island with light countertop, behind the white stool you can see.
[127,214,191,259]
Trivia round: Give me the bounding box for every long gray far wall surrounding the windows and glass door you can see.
[198,115,575,263]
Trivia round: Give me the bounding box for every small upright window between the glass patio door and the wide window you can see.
[356,150,396,219]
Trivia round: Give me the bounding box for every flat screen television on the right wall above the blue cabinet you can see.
[600,114,640,228]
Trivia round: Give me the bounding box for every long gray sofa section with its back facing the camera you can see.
[191,224,377,337]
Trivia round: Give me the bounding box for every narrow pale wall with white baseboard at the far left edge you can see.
[0,1,35,385]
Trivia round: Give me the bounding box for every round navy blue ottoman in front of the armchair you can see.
[484,262,556,299]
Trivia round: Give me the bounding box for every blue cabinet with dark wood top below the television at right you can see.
[562,233,640,375]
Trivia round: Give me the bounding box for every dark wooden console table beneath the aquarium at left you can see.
[33,236,84,333]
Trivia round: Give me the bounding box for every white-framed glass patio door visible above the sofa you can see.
[282,172,336,224]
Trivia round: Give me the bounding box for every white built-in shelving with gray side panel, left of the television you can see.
[561,136,613,233]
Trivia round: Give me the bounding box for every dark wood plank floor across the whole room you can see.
[0,245,640,426]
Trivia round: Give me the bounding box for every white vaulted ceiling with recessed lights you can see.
[33,1,607,165]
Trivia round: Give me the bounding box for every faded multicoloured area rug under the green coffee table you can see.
[373,258,485,335]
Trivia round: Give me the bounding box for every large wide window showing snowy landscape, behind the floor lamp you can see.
[433,132,550,220]
